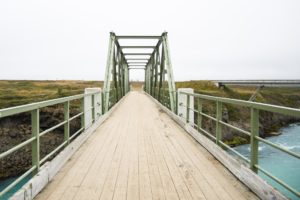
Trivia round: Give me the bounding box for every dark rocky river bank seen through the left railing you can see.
[0,108,80,180]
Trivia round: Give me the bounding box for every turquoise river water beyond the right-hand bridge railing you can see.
[235,124,300,199]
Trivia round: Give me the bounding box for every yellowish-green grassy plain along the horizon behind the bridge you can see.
[0,80,300,109]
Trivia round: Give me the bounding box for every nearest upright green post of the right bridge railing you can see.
[250,108,259,172]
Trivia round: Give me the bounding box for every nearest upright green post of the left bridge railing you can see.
[31,109,40,174]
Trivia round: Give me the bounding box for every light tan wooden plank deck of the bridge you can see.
[36,92,257,200]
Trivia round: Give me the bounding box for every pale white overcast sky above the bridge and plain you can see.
[0,0,300,80]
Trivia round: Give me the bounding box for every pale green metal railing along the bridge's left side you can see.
[0,92,109,199]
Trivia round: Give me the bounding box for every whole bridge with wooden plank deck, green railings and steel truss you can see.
[0,33,300,200]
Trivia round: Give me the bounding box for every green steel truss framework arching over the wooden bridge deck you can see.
[103,32,176,112]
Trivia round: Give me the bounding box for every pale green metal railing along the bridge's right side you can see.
[178,91,300,197]
